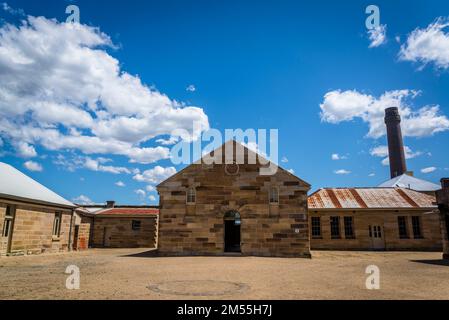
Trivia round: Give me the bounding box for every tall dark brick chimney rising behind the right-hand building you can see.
[385,107,407,179]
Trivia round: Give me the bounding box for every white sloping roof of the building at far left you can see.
[0,162,75,207]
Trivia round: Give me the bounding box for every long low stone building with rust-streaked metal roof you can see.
[308,188,442,251]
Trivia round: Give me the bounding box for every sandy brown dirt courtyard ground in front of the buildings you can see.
[0,249,449,300]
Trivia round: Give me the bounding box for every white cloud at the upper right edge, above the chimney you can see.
[399,17,449,69]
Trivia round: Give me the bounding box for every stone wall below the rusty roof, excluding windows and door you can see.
[309,209,442,251]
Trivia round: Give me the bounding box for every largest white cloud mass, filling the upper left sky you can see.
[0,16,209,164]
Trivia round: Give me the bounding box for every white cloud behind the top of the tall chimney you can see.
[320,90,449,138]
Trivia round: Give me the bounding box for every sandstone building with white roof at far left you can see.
[0,162,76,256]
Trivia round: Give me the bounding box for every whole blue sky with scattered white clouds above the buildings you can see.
[0,0,449,204]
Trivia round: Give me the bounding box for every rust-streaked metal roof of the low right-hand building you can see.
[308,188,436,209]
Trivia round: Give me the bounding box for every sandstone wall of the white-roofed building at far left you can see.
[0,203,72,255]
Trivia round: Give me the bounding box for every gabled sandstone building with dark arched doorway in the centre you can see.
[157,141,310,257]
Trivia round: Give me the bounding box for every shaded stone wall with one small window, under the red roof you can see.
[91,216,158,248]
